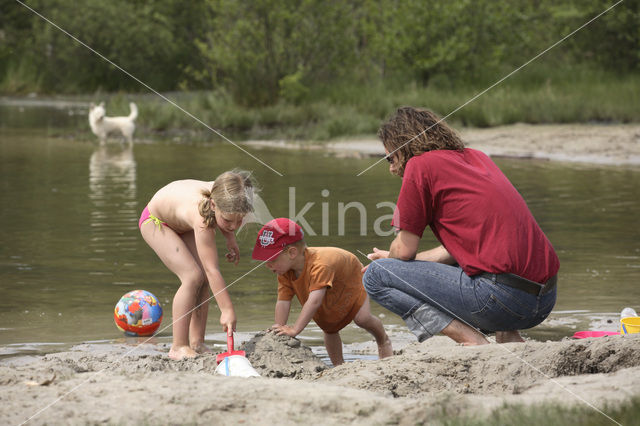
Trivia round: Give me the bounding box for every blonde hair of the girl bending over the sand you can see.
[198,169,255,228]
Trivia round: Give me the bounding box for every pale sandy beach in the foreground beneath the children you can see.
[0,333,640,425]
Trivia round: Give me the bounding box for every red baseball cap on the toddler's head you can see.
[251,217,304,261]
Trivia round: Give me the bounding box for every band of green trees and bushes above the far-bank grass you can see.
[0,0,640,95]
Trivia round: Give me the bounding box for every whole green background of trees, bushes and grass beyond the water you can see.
[0,0,640,135]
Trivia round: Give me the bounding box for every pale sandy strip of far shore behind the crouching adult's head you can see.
[243,124,640,166]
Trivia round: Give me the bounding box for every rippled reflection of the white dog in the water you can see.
[89,144,139,285]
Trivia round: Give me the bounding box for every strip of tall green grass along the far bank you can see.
[5,67,640,141]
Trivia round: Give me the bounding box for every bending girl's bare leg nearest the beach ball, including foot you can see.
[140,222,204,359]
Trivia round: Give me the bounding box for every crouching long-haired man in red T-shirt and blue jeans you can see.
[364,107,560,345]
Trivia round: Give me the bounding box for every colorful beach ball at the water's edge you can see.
[113,290,162,336]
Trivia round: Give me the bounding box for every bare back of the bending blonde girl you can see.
[148,179,213,232]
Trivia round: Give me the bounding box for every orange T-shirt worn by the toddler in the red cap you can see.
[278,247,367,333]
